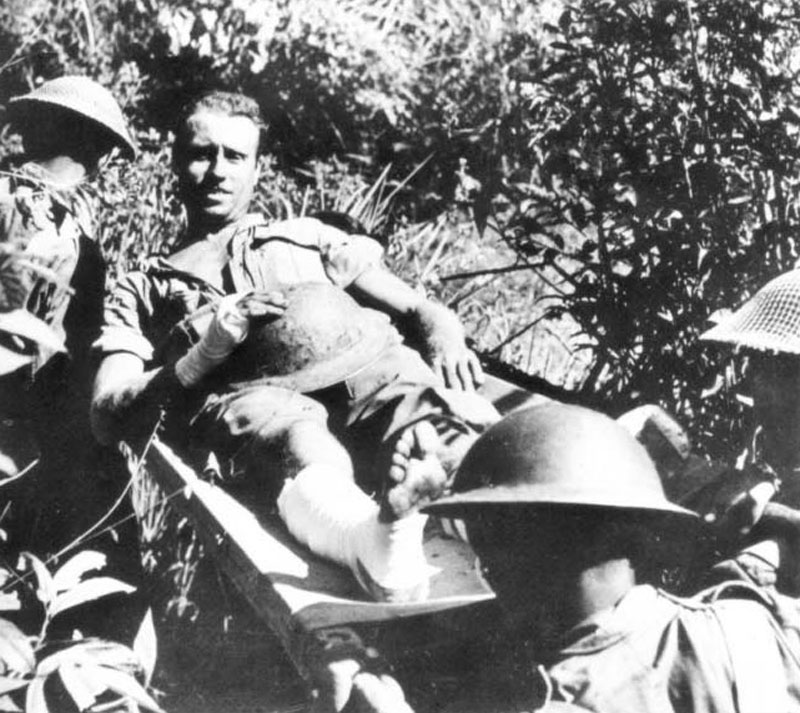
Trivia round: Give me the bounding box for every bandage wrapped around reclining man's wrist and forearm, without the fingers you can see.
[175,294,250,388]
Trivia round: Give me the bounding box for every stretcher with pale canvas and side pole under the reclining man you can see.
[145,377,544,700]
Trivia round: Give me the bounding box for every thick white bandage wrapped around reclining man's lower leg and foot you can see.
[278,464,433,601]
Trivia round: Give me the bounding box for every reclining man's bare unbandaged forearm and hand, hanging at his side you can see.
[348,268,483,391]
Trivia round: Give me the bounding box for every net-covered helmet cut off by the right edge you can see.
[700,269,800,354]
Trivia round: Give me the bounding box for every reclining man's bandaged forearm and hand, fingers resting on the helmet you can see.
[175,292,286,388]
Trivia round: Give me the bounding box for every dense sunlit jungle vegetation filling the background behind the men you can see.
[0,0,800,704]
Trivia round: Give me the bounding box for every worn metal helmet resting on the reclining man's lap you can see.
[230,282,399,393]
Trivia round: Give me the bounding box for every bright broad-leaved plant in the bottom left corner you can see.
[0,550,160,713]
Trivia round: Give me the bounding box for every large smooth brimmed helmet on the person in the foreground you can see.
[425,403,697,518]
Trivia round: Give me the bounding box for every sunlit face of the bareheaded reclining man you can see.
[174,110,259,228]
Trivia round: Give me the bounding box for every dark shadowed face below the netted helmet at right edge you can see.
[748,354,800,471]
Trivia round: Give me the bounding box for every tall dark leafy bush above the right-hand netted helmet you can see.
[482,0,800,456]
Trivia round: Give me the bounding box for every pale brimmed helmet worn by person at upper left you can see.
[9,76,136,158]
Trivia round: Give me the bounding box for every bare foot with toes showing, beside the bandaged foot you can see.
[380,421,447,522]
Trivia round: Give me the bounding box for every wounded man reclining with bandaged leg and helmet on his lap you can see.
[92,92,498,600]
